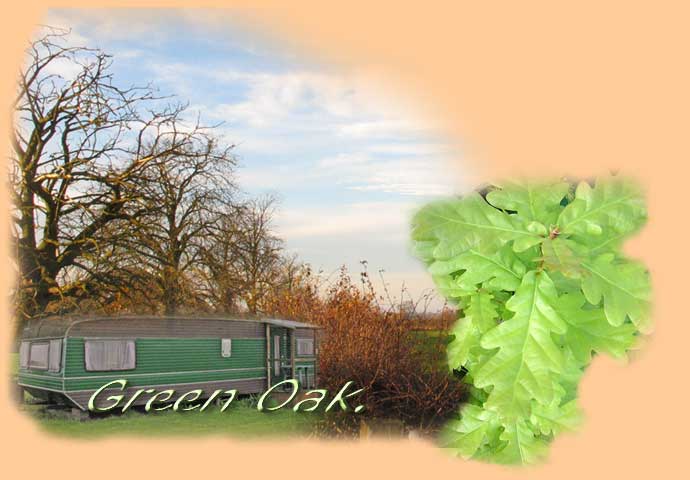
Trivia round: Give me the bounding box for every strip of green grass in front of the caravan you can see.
[21,402,318,439]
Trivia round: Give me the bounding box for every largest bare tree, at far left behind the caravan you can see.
[10,29,208,319]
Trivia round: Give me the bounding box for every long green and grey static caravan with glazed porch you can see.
[17,316,319,410]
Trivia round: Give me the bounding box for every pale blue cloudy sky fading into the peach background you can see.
[37,9,464,307]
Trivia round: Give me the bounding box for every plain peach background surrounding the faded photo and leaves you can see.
[0,0,690,480]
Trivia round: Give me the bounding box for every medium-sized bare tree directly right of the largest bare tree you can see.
[125,130,236,314]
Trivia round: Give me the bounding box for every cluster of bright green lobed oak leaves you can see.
[412,177,651,464]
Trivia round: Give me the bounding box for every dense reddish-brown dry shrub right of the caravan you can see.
[266,269,464,433]
